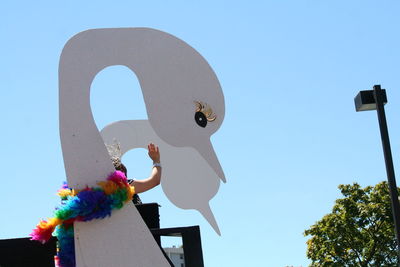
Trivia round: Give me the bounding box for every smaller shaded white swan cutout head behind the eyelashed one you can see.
[101,120,220,234]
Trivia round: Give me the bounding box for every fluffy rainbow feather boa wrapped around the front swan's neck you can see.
[30,171,135,267]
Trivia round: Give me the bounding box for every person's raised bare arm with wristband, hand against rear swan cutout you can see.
[132,143,161,194]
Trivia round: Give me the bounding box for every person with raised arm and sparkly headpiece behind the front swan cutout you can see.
[107,143,161,204]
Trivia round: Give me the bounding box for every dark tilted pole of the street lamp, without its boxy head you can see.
[374,85,400,254]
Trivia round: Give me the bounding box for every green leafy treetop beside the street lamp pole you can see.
[304,182,399,267]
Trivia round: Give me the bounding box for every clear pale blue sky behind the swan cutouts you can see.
[0,0,400,267]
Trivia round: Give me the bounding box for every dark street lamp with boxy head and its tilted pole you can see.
[354,85,400,255]
